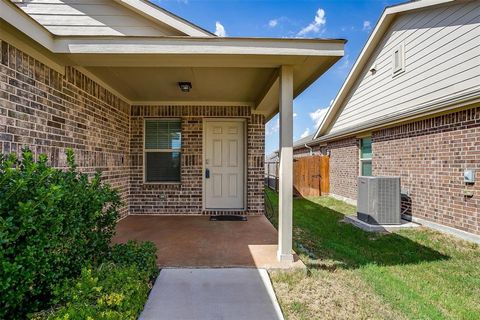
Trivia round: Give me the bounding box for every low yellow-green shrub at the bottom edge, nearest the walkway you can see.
[33,263,150,320]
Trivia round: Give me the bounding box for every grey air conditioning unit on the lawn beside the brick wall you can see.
[357,176,401,224]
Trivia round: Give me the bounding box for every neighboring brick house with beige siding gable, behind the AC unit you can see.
[295,0,480,235]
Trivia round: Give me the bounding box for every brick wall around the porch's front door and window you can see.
[0,42,265,216]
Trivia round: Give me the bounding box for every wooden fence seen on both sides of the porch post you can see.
[265,156,330,197]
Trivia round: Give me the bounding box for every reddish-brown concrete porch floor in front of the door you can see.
[113,215,305,269]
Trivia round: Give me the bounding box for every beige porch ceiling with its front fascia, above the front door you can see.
[54,37,345,120]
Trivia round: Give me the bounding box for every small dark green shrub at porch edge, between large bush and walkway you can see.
[107,241,158,279]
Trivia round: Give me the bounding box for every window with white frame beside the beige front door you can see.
[144,119,182,182]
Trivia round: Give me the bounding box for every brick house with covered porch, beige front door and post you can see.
[0,0,345,260]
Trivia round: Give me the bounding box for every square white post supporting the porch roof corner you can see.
[277,66,293,261]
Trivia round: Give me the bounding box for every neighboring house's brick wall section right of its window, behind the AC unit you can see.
[372,105,480,234]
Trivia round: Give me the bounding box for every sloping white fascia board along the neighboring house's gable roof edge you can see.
[314,0,456,139]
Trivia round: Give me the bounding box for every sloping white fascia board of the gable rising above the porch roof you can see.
[115,0,214,37]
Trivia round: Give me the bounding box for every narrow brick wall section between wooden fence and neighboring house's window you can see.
[327,138,359,199]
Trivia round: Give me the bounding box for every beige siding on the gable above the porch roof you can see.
[13,0,182,36]
